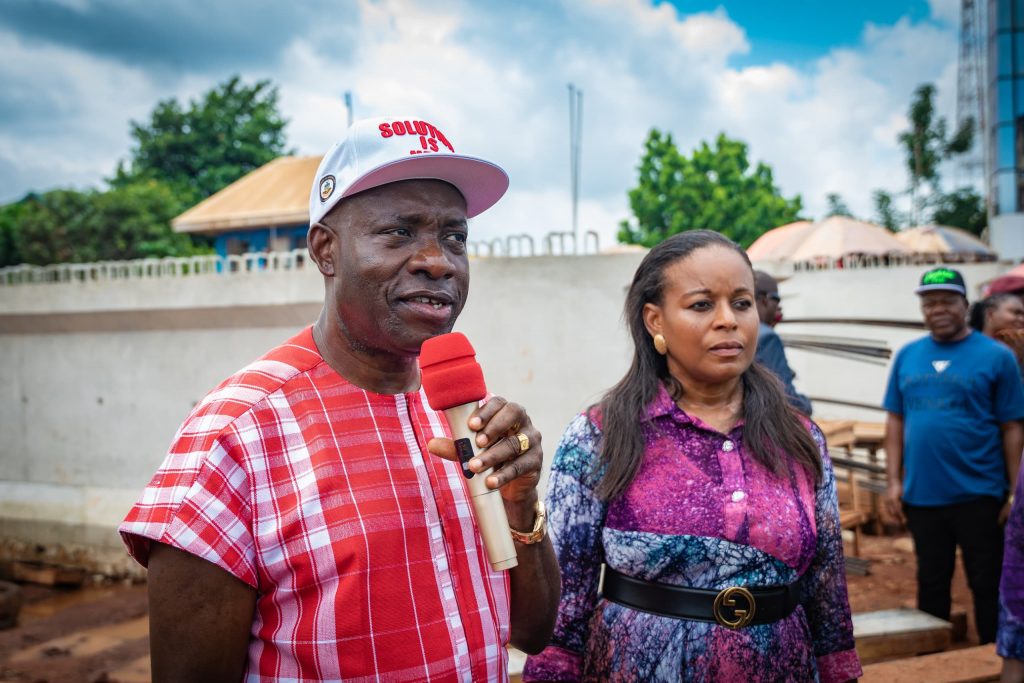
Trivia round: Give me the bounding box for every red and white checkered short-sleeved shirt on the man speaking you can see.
[120,329,509,682]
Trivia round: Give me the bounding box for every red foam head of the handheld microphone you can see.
[420,332,487,411]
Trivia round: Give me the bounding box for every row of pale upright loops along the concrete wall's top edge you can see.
[0,230,600,287]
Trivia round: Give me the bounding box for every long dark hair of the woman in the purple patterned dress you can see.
[594,230,822,501]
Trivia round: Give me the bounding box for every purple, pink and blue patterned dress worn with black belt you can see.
[523,388,861,682]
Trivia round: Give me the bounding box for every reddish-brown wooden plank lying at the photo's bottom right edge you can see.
[860,643,1002,683]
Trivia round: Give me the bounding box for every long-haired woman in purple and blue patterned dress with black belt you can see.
[523,230,861,682]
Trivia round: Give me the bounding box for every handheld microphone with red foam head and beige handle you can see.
[420,332,519,570]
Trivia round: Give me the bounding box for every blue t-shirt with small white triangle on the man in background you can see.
[885,331,1024,506]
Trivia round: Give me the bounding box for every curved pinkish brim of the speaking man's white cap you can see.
[338,154,509,218]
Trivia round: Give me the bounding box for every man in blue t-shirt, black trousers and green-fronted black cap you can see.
[885,267,1024,643]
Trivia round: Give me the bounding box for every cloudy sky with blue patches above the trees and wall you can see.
[0,0,959,247]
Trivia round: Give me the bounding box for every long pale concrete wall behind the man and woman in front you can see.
[0,253,1008,570]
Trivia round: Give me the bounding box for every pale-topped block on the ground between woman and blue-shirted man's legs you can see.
[853,608,952,661]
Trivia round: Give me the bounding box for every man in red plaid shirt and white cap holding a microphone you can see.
[121,114,559,683]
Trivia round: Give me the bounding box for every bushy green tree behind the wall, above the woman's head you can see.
[618,129,802,247]
